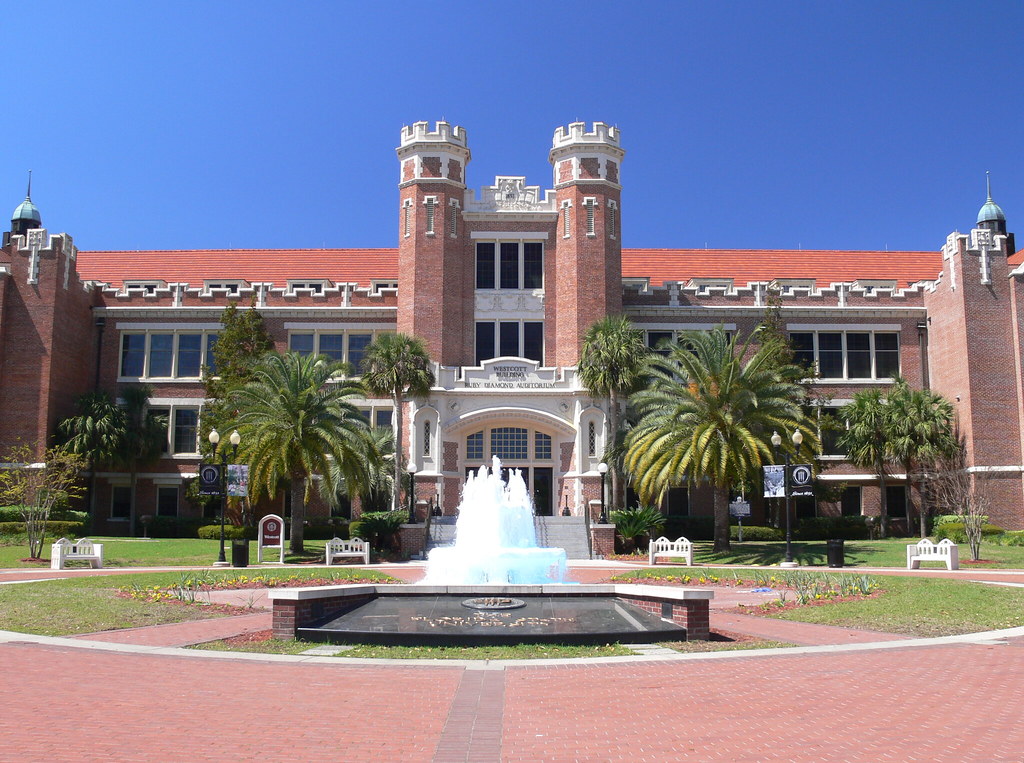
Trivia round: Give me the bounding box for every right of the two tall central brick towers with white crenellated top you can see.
[549,122,626,366]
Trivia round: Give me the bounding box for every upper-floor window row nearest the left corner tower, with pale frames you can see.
[121,332,217,379]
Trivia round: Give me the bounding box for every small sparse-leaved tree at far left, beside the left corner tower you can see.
[0,446,86,559]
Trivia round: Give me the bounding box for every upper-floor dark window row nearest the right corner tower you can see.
[790,331,899,379]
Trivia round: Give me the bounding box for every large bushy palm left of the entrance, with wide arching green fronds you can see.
[231,352,368,554]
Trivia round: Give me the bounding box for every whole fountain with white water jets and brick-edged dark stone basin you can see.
[278,458,712,645]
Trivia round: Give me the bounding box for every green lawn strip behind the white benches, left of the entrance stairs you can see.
[0,536,339,567]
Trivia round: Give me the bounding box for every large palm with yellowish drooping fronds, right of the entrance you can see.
[626,327,818,551]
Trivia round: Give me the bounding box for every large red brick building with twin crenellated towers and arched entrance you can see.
[0,122,1024,533]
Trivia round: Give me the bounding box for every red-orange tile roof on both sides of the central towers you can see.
[78,249,946,287]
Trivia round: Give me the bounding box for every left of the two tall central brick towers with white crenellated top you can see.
[397,122,472,365]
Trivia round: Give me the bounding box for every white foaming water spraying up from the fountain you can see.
[423,456,565,585]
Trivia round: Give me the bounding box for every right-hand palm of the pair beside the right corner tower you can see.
[888,377,958,538]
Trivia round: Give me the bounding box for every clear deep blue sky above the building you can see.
[0,0,1024,250]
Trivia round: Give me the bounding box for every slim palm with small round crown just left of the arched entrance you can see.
[361,334,434,511]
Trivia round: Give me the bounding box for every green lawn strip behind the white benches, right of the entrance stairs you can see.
[693,538,1024,569]
